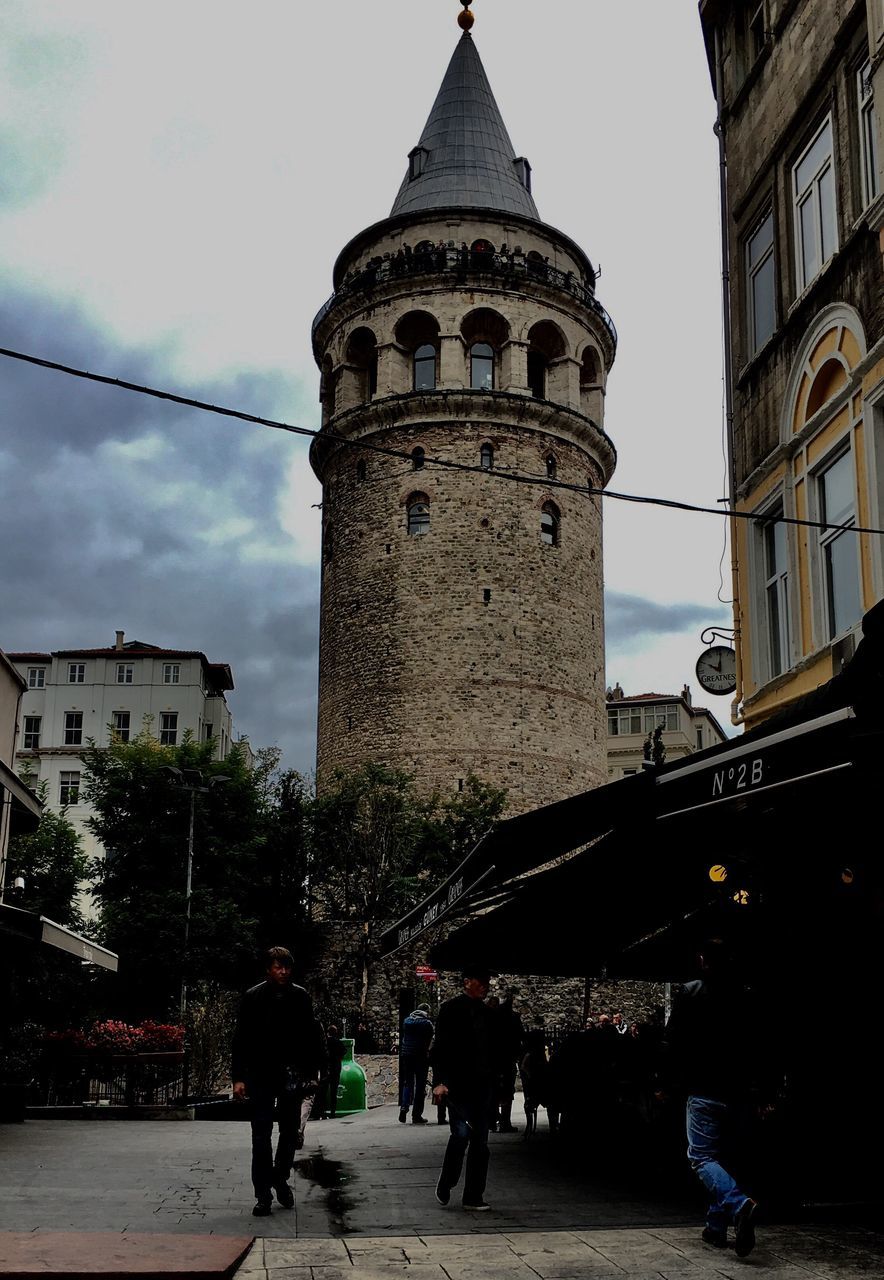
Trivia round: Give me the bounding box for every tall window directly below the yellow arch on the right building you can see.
[816,451,861,640]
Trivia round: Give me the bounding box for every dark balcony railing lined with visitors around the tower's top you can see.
[312,244,617,351]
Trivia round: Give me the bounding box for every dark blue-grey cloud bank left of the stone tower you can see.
[0,292,319,771]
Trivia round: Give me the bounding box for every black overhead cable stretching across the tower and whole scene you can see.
[6,347,884,536]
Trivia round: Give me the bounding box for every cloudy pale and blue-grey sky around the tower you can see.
[0,0,733,772]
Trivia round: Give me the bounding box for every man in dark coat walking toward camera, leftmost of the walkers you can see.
[232,947,325,1217]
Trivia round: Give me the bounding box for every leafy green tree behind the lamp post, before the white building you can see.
[84,727,310,1016]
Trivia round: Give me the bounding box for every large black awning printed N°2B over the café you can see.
[430,708,884,980]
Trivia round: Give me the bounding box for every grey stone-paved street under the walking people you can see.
[0,1107,884,1280]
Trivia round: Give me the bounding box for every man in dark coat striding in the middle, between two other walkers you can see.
[431,965,498,1212]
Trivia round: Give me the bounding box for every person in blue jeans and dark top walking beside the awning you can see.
[664,938,770,1258]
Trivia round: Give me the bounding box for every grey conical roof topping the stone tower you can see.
[390,31,540,220]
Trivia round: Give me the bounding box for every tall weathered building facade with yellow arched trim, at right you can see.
[700,0,884,728]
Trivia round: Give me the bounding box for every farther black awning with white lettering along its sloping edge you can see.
[380,774,654,955]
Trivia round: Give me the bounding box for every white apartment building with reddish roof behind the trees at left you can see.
[8,631,248,875]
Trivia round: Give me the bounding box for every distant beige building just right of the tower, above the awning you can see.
[605,685,727,780]
